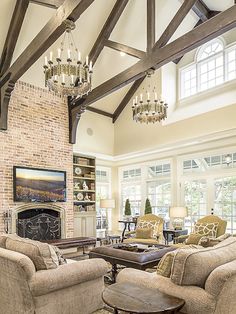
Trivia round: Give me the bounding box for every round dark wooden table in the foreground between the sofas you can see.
[102,282,185,314]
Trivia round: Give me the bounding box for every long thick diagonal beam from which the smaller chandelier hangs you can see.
[72,5,236,112]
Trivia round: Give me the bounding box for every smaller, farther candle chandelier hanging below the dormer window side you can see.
[132,69,168,123]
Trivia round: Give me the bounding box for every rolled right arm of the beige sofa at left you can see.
[29,258,108,296]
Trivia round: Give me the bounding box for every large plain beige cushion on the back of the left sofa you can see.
[6,237,59,270]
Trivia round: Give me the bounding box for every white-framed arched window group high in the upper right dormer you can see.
[180,38,236,98]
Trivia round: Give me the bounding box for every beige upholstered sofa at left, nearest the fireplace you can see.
[0,237,107,314]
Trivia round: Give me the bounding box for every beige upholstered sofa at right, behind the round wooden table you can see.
[117,237,236,314]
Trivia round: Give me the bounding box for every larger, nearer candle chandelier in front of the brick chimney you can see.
[43,20,93,97]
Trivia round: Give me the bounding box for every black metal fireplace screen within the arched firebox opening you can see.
[16,208,61,241]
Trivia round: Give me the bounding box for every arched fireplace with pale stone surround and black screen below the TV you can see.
[12,204,64,241]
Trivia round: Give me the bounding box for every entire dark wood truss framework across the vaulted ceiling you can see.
[0,0,236,143]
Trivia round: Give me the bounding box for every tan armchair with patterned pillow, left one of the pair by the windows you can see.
[124,214,164,244]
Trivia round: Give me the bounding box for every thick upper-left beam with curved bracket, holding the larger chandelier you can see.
[0,0,94,130]
